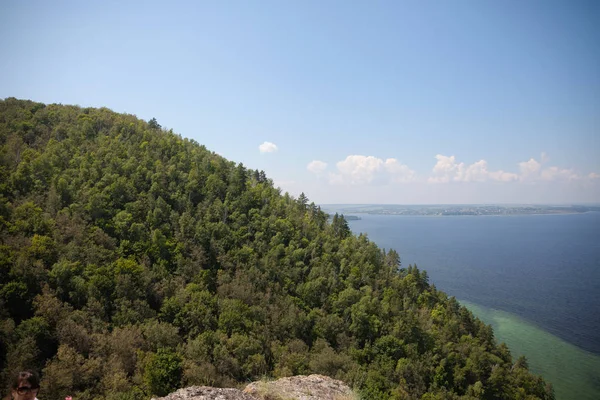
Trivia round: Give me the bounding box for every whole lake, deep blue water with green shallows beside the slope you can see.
[342,213,600,398]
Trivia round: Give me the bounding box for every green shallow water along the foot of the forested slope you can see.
[460,300,600,400]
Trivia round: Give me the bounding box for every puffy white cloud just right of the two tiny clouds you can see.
[329,155,415,185]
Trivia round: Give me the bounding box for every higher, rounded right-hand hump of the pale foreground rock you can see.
[244,375,357,400]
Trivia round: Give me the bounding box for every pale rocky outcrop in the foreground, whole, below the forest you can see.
[153,375,358,400]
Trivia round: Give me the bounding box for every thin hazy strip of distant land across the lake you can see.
[322,204,600,219]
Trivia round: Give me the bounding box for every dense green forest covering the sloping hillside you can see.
[0,98,554,400]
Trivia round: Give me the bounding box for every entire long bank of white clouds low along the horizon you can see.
[308,153,600,204]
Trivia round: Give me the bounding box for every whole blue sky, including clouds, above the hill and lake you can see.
[0,0,600,204]
